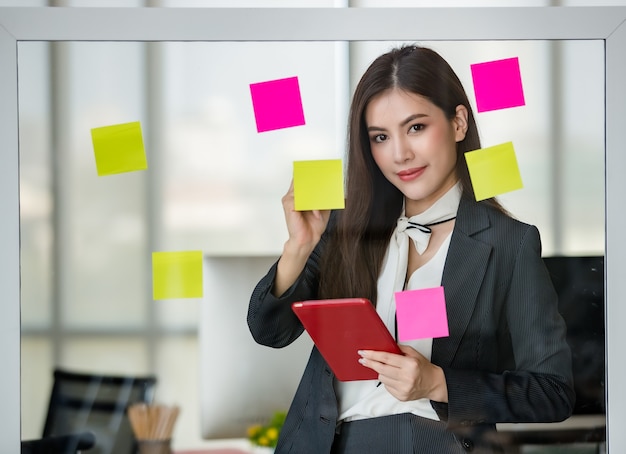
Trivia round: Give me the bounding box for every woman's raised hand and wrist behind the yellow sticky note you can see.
[272,180,330,296]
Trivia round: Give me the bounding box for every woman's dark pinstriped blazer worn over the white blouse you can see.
[248,197,575,454]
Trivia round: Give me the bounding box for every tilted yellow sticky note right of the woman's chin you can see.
[465,142,523,201]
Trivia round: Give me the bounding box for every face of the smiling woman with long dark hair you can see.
[365,88,467,216]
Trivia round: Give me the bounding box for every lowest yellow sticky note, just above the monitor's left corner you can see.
[152,251,202,300]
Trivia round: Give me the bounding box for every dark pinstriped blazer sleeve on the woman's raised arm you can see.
[247,221,330,348]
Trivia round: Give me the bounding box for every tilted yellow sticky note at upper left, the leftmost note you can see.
[91,121,148,176]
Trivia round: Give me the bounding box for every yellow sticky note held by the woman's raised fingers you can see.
[293,159,345,211]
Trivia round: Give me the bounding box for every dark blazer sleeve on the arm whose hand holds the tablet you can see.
[433,226,575,426]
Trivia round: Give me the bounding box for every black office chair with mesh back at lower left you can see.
[43,369,156,454]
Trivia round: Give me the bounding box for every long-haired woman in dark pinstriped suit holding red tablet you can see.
[248,47,574,454]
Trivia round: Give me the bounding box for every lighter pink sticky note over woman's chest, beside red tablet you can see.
[395,287,449,342]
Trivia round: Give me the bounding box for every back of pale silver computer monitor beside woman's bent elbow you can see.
[199,256,313,439]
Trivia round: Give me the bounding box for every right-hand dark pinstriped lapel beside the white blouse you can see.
[432,197,491,366]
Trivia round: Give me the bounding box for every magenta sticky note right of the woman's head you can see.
[470,57,525,112]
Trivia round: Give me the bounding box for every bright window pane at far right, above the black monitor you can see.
[557,40,604,255]
